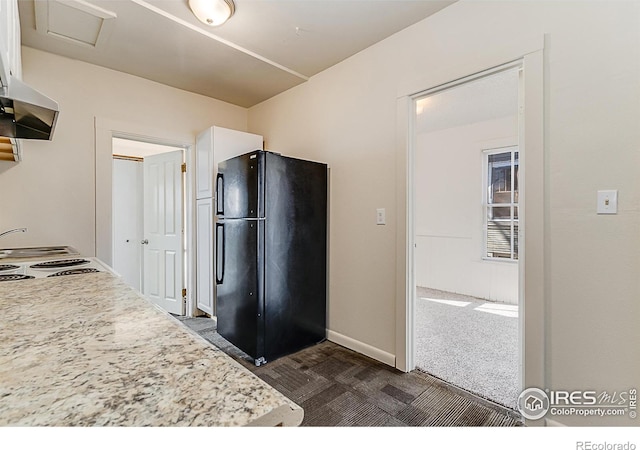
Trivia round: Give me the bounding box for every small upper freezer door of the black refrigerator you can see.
[216,151,264,219]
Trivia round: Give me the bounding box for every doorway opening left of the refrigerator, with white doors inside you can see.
[112,137,187,315]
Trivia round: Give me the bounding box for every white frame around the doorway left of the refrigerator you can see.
[95,117,196,316]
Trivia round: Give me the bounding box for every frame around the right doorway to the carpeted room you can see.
[396,44,548,412]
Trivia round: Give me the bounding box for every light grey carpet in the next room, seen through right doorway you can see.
[414,287,521,409]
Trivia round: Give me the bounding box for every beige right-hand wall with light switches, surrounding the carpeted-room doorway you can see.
[249,2,640,425]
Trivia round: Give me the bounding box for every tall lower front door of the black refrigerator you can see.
[216,219,264,360]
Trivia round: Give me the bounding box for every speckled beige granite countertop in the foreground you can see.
[0,272,303,426]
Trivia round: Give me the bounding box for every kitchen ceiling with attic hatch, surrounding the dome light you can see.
[18,0,455,107]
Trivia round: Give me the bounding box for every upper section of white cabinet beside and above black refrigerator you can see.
[196,127,262,199]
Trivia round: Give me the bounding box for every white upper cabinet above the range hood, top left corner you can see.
[0,0,22,86]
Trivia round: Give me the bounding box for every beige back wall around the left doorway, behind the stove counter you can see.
[0,47,247,255]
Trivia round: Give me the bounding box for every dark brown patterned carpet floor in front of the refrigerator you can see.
[177,317,522,427]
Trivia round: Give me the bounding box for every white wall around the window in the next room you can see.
[414,111,518,304]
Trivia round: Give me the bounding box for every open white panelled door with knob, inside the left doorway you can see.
[142,150,184,314]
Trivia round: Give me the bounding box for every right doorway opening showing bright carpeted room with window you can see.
[410,63,524,409]
